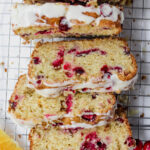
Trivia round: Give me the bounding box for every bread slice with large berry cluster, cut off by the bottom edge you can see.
[29,108,135,150]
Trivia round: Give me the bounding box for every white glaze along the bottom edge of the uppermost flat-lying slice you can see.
[28,74,138,97]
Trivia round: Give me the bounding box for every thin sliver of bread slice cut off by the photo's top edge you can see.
[24,0,132,6]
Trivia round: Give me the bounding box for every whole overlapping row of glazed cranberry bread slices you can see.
[8,0,137,150]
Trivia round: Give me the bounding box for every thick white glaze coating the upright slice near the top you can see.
[11,3,124,28]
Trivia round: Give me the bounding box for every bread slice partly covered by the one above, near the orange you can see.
[8,75,116,127]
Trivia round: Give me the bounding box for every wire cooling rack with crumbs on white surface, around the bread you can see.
[0,0,150,150]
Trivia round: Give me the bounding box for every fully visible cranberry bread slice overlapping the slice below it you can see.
[28,38,137,97]
